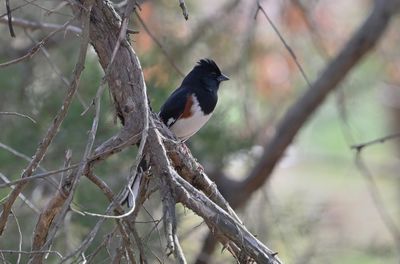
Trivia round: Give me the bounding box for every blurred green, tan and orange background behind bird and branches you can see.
[0,0,400,264]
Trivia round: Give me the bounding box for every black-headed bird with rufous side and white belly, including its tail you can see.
[121,59,229,210]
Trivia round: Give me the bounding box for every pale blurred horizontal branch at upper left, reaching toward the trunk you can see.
[0,17,82,34]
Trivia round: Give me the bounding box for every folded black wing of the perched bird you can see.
[160,86,191,127]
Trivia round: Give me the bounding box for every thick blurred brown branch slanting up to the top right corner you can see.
[227,0,399,207]
